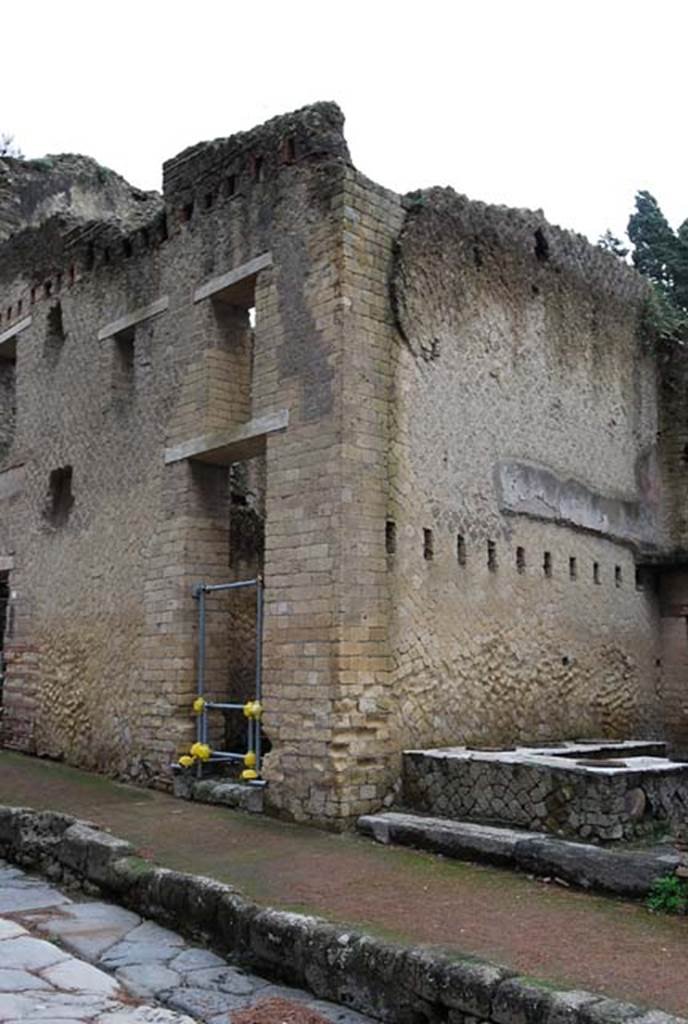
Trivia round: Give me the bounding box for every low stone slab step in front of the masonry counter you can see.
[357,811,682,898]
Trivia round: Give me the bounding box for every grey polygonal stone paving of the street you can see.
[0,861,372,1024]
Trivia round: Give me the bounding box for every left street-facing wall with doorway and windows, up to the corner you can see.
[0,104,362,817]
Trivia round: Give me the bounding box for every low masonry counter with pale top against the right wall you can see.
[402,750,688,843]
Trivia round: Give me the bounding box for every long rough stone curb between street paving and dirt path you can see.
[0,807,688,1024]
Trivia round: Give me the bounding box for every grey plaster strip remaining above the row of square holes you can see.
[495,461,656,544]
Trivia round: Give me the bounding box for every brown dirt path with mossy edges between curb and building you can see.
[0,752,688,1014]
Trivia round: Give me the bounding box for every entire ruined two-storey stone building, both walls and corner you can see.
[0,104,683,823]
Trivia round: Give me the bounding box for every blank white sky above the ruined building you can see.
[0,0,688,240]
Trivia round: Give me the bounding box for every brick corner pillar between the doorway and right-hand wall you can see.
[259,165,402,828]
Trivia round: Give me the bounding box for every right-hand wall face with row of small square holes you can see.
[388,190,660,765]
